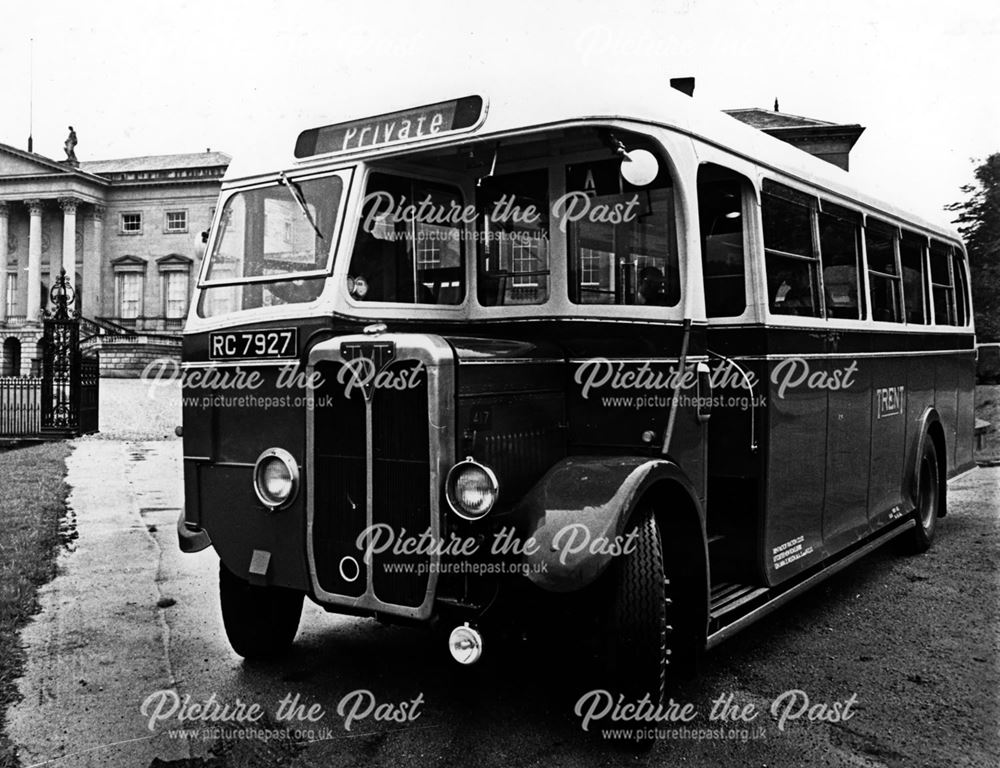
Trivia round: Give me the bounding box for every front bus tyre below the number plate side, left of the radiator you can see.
[219,562,303,659]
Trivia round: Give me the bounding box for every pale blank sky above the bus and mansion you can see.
[0,0,1000,228]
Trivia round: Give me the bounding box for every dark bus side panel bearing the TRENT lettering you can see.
[868,352,916,528]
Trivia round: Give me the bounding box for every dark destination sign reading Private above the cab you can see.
[295,96,483,157]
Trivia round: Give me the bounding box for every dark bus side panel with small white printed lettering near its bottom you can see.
[764,360,828,585]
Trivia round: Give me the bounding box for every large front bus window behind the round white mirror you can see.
[553,158,681,307]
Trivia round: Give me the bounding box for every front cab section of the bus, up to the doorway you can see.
[179,97,708,696]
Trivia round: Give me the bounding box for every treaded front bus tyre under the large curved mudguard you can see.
[606,511,673,706]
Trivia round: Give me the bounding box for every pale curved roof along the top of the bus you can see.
[224,79,960,240]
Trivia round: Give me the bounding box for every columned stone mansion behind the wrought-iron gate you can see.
[0,143,230,376]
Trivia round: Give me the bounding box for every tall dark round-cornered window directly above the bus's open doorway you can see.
[698,163,749,317]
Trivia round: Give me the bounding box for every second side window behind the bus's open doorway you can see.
[819,201,863,320]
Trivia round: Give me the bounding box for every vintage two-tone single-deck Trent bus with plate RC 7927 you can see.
[178,82,975,694]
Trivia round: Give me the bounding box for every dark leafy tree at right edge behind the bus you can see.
[947,152,1000,341]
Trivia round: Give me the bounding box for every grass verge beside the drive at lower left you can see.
[0,442,71,768]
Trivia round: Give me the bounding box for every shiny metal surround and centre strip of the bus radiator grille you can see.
[306,333,455,619]
